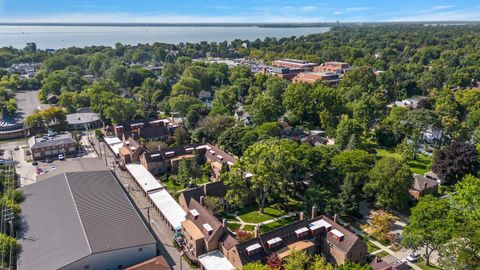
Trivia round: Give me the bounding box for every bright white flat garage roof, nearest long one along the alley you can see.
[148,188,187,229]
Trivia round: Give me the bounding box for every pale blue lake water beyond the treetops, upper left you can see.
[0,26,329,49]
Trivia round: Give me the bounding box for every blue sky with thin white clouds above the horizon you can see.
[0,0,480,22]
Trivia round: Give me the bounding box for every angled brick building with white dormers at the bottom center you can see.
[222,213,368,269]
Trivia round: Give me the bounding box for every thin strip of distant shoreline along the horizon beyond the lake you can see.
[0,21,480,28]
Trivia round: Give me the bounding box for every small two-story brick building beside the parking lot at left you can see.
[28,133,77,160]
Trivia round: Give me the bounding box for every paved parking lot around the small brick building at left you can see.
[0,133,98,186]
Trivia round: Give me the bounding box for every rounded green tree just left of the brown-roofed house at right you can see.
[363,157,413,209]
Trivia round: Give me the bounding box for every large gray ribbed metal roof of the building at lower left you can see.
[18,171,155,269]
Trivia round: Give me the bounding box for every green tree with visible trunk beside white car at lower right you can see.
[402,195,454,265]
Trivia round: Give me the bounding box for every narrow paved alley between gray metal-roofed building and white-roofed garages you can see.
[92,136,194,270]
